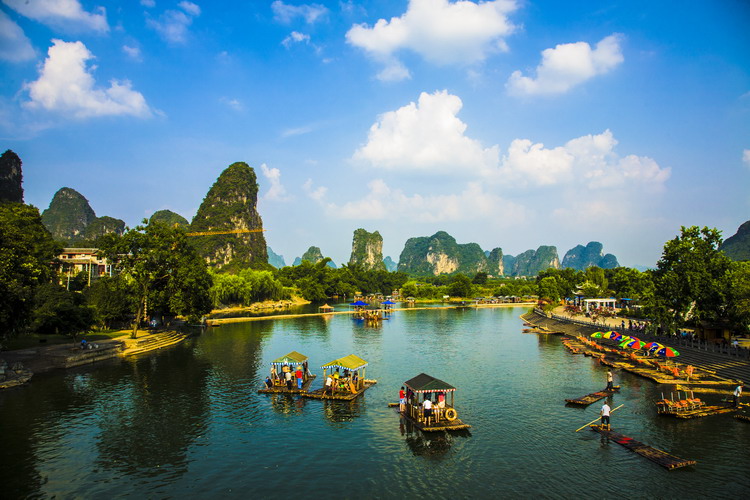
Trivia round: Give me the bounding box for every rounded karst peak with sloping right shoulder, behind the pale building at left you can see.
[42,187,125,246]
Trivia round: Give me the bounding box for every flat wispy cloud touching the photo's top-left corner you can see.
[2,0,109,33]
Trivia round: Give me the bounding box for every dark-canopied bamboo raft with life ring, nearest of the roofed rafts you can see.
[394,373,471,432]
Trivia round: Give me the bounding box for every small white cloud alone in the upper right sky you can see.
[505,33,624,95]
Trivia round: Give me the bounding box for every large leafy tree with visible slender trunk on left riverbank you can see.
[100,220,211,338]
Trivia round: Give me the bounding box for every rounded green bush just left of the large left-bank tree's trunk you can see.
[84,275,136,329]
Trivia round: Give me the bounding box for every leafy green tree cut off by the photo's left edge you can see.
[0,202,62,337]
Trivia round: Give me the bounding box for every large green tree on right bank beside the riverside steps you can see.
[652,226,731,326]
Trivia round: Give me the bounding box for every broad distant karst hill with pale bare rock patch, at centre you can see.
[398,231,490,276]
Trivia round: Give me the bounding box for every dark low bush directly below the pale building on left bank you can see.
[31,283,94,337]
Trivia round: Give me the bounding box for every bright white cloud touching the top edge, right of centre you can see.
[346,0,517,80]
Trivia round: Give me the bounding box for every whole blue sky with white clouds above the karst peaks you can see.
[0,0,750,266]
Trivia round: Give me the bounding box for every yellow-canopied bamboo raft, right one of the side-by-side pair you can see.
[303,354,378,401]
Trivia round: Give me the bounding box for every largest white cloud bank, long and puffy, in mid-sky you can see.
[352,90,670,190]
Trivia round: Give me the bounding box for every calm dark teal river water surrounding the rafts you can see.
[0,308,750,499]
